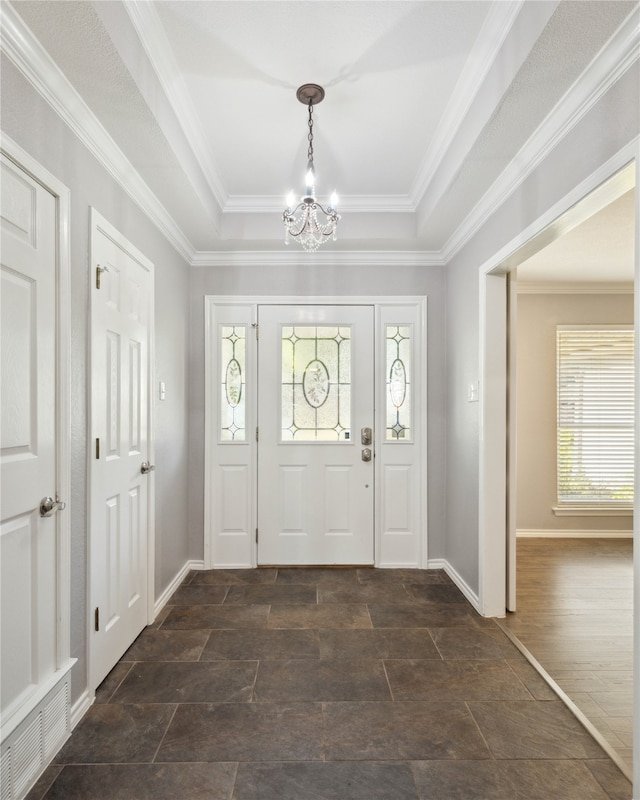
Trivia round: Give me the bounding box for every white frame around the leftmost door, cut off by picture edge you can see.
[0,133,76,740]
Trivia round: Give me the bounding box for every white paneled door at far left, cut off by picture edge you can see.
[0,157,59,728]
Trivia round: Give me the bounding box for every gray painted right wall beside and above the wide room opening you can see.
[446,66,640,592]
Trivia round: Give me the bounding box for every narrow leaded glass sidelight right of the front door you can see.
[385,325,412,442]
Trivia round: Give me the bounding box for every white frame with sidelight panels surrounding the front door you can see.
[203,295,428,569]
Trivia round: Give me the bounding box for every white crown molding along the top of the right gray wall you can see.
[442,7,640,261]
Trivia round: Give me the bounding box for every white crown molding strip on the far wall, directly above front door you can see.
[191,250,445,267]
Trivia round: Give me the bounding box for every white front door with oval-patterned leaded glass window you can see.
[258,305,375,565]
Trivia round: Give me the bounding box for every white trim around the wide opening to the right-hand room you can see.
[478,139,640,620]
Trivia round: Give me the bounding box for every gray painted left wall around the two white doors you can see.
[1,59,189,701]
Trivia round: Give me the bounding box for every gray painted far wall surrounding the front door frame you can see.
[189,262,446,558]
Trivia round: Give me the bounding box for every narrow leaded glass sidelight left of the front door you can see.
[220,325,247,442]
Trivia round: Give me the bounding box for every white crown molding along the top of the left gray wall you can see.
[0,2,195,261]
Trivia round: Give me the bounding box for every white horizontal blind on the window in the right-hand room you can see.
[557,326,634,506]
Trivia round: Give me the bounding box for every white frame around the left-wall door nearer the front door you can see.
[87,207,155,698]
